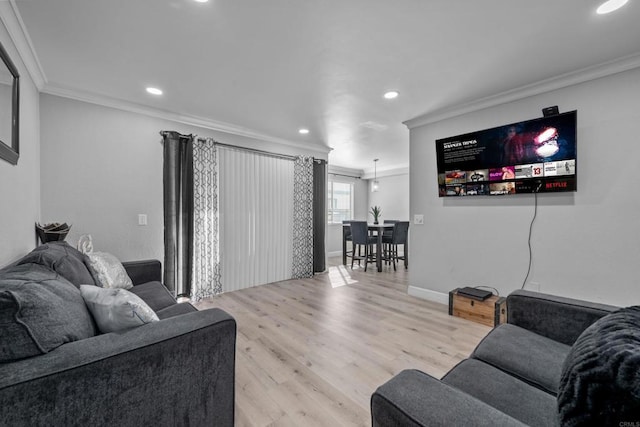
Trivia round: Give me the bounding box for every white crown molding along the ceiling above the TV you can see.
[403,53,640,129]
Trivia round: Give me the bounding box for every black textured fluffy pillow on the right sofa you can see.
[558,306,640,427]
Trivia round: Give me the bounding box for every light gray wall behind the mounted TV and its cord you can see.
[409,69,640,305]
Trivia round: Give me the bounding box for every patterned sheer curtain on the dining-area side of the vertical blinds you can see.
[292,156,314,279]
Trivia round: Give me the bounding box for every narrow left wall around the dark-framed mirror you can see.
[0,17,40,267]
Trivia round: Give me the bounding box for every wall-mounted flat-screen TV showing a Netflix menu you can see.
[435,110,578,198]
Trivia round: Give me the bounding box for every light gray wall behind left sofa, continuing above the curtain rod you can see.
[40,94,326,260]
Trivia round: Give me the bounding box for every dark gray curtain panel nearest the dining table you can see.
[313,160,327,273]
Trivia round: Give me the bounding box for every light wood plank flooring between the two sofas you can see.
[196,258,490,427]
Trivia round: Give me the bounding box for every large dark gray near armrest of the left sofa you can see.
[0,309,236,426]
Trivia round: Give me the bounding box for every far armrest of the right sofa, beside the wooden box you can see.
[507,290,619,345]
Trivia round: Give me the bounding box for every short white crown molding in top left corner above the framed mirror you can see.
[0,0,47,90]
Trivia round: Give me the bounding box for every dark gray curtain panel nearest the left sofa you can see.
[160,131,193,296]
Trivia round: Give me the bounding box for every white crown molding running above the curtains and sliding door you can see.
[42,83,331,155]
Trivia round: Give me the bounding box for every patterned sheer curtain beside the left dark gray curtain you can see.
[191,138,222,301]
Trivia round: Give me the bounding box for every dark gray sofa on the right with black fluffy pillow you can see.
[371,291,640,427]
